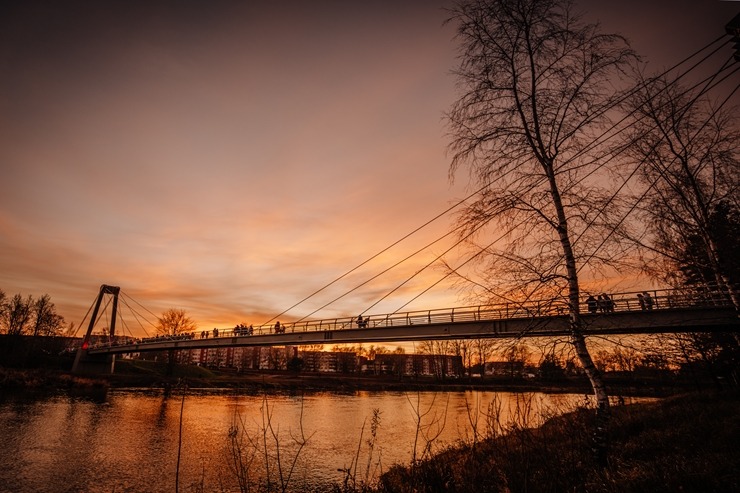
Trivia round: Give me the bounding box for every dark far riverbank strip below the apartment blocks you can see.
[0,360,686,396]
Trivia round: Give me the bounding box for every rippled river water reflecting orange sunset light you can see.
[0,389,648,493]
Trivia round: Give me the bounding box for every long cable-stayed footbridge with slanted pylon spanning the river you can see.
[73,285,740,372]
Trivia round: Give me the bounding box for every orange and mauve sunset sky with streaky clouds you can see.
[0,0,740,336]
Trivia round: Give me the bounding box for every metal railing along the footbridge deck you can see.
[91,289,732,346]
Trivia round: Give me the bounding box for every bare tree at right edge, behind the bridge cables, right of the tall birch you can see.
[627,79,740,310]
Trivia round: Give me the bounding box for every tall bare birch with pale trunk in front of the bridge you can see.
[448,0,634,458]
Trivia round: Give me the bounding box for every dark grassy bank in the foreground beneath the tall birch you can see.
[370,391,740,493]
